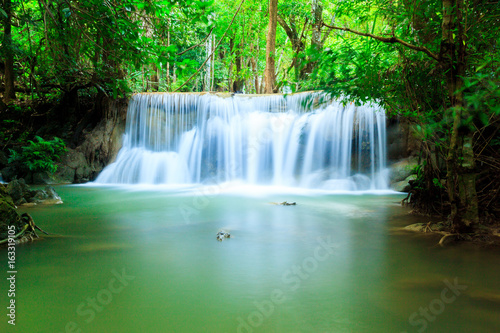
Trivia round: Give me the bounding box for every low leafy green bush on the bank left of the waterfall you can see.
[9,136,67,173]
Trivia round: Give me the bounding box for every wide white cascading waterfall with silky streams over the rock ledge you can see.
[96,93,387,190]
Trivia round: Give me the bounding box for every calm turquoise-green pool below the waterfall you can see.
[0,186,500,332]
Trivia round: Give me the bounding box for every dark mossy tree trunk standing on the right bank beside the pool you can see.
[441,0,478,231]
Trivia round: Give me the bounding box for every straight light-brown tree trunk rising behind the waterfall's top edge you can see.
[264,0,278,94]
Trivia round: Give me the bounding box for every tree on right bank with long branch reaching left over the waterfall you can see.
[324,0,498,231]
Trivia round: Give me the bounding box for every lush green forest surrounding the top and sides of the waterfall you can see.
[0,0,500,232]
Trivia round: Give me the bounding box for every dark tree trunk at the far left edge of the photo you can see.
[3,0,16,103]
